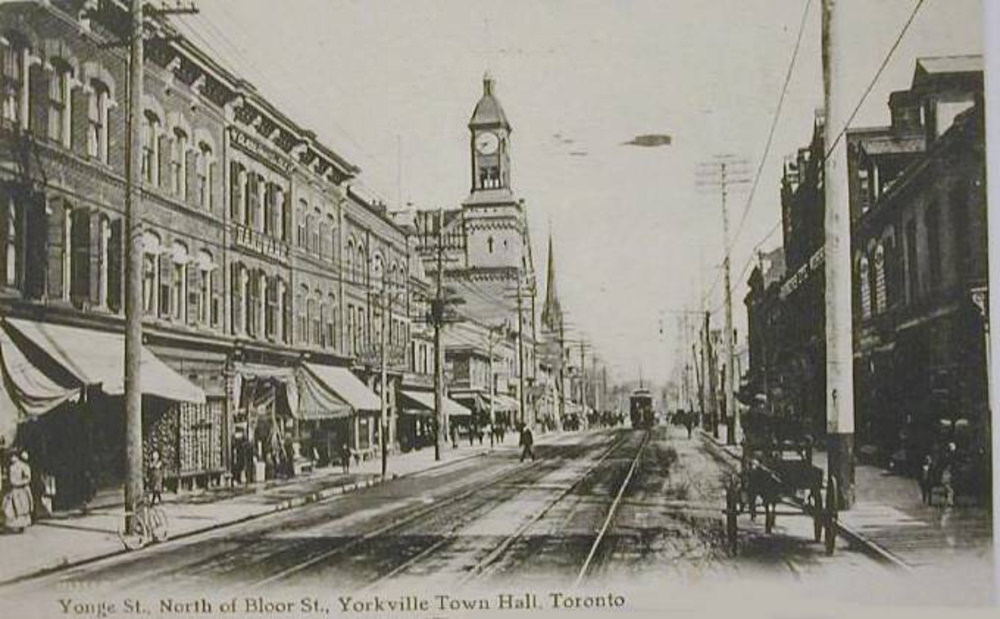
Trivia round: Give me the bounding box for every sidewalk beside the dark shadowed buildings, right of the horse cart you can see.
[702,426,992,569]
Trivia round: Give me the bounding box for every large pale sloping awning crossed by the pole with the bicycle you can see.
[6,318,205,404]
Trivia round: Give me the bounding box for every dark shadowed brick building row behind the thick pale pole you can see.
[746,56,989,504]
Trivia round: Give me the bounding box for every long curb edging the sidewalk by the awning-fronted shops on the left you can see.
[0,449,490,587]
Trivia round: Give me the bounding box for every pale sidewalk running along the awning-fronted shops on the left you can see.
[0,434,516,585]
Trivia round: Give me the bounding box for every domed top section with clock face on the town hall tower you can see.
[469,73,511,193]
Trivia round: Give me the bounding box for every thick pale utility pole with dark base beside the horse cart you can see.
[822,0,854,509]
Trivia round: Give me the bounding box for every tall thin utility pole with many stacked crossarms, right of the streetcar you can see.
[699,155,750,445]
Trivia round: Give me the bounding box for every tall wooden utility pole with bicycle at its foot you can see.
[125,0,144,534]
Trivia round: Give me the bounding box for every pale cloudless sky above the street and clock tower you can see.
[172,0,983,382]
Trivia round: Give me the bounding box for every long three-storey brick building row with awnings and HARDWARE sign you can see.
[0,0,421,506]
